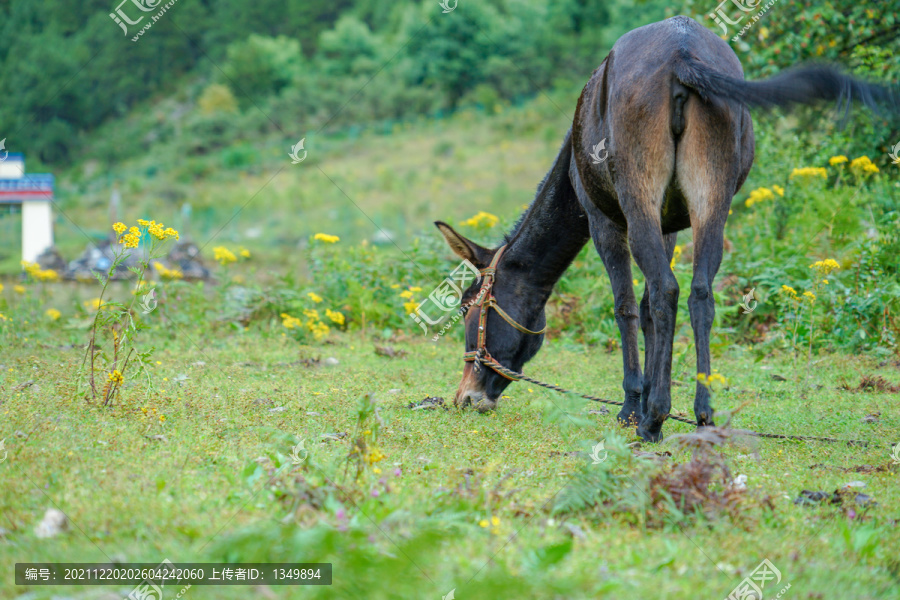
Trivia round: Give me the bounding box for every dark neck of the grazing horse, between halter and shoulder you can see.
[504,136,590,294]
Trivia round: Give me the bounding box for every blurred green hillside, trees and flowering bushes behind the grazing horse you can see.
[0,0,900,352]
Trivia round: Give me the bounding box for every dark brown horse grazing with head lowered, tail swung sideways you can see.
[435,16,898,441]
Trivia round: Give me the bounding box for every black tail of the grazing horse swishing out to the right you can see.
[675,52,900,116]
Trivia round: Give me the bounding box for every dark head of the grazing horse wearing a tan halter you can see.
[435,221,552,412]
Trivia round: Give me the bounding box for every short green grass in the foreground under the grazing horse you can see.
[0,324,900,599]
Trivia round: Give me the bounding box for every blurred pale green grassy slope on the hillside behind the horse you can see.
[0,93,577,275]
